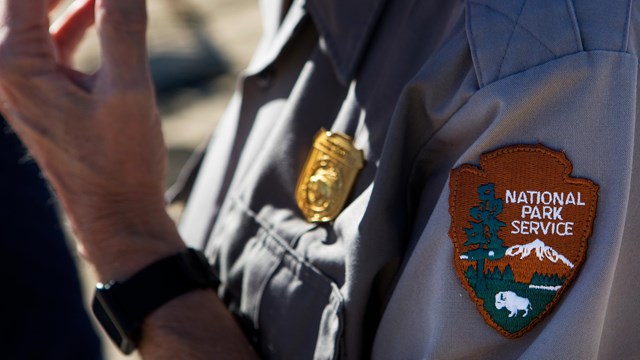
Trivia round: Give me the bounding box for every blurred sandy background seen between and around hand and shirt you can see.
[59,0,261,360]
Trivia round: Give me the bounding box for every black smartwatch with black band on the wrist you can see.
[91,249,218,354]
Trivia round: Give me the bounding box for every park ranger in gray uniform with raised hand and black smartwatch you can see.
[0,0,640,359]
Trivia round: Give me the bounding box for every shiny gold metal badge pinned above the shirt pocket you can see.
[296,129,364,222]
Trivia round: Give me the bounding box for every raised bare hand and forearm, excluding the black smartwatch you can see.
[0,0,254,359]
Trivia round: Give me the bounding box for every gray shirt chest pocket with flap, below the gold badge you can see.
[207,200,344,359]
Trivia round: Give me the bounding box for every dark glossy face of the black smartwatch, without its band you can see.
[91,283,140,355]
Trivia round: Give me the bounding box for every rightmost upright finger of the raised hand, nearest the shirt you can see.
[96,0,148,84]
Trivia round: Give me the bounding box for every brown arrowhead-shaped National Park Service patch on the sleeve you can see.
[449,145,598,338]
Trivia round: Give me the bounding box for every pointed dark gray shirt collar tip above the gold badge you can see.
[305,0,386,84]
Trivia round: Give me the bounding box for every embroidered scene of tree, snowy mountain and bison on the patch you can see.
[458,183,575,335]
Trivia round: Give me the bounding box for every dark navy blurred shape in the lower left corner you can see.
[0,114,101,360]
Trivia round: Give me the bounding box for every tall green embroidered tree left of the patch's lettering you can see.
[462,183,507,291]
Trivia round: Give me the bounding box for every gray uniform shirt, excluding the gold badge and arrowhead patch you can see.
[180,0,640,359]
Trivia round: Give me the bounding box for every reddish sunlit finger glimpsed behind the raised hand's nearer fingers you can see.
[49,0,95,66]
